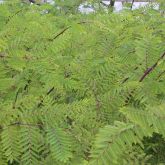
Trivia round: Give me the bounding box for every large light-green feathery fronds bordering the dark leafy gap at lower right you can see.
[92,104,165,164]
